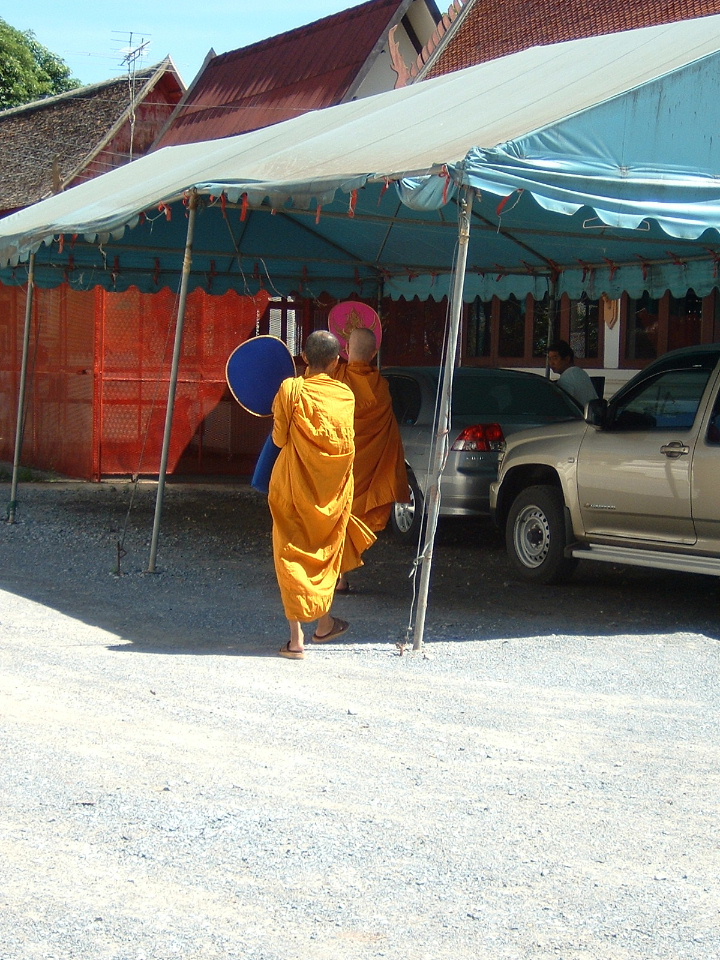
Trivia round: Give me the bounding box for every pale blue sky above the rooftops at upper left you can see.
[0,0,360,84]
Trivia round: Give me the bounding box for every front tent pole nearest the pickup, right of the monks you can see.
[413,191,473,650]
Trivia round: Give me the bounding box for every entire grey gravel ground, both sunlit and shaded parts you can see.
[0,483,720,960]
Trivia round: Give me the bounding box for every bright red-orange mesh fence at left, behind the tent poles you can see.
[0,286,268,479]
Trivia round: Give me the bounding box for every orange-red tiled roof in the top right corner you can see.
[422,0,720,78]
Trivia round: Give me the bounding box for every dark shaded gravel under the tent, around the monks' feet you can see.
[0,484,720,656]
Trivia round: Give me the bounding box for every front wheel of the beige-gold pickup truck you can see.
[505,486,577,583]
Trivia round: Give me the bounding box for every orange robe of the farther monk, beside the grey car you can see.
[335,361,410,531]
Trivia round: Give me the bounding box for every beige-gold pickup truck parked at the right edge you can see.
[490,343,720,583]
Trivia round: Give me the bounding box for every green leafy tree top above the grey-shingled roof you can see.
[0,18,80,110]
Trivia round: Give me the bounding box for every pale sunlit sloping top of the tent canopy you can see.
[0,16,720,284]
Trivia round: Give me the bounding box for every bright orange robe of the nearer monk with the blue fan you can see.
[268,373,375,623]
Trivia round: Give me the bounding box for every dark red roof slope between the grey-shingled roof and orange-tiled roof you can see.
[152,0,407,147]
